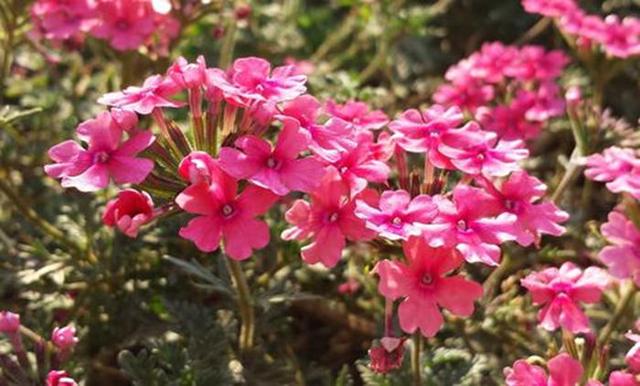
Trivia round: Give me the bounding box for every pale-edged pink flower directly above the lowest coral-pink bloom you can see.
[356,190,437,240]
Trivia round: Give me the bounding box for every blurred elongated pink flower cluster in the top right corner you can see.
[522,0,640,59]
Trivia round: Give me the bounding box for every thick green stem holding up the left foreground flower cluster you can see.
[225,258,255,356]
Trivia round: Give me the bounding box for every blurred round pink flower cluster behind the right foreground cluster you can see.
[433,42,569,140]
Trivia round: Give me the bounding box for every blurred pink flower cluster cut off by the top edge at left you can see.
[31,0,180,55]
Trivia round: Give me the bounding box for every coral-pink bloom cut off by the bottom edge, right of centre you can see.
[504,353,584,386]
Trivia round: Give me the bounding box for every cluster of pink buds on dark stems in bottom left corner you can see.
[0,311,78,386]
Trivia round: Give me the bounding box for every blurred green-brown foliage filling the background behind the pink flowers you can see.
[0,0,640,386]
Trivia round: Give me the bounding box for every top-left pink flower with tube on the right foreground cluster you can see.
[389,105,464,169]
